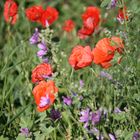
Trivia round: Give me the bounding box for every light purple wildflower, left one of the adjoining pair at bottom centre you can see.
[79,108,90,128]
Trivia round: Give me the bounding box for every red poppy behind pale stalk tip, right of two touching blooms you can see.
[41,7,59,27]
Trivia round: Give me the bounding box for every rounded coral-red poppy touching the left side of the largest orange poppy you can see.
[69,46,93,70]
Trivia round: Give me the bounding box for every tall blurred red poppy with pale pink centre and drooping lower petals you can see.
[78,6,100,39]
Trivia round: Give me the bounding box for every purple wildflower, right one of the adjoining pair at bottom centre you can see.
[91,110,101,125]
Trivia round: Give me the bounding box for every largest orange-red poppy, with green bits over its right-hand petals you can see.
[92,37,124,68]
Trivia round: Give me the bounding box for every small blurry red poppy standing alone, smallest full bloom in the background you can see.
[63,19,75,32]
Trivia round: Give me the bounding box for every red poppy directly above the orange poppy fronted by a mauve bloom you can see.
[32,63,52,83]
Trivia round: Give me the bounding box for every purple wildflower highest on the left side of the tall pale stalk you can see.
[29,28,39,45]
